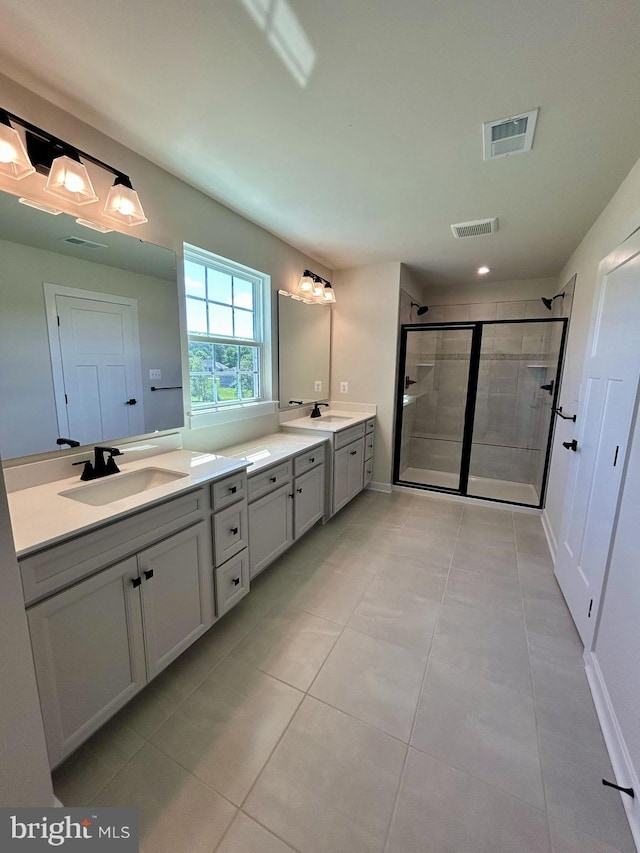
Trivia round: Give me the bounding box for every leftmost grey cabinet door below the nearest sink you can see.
[27,557,146,767]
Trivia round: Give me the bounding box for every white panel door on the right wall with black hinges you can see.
[555,244,640,647]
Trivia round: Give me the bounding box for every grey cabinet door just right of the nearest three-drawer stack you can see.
[249,483,293,578]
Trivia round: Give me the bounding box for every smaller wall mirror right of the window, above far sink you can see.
[278,293,331,409]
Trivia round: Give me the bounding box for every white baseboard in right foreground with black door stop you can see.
[584,651,640,851]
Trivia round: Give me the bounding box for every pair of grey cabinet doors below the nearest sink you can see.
[27,510,214,767]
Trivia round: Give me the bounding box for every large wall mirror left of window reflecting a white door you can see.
[0,193,184,459]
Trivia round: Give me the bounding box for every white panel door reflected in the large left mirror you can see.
[45,285,144,444]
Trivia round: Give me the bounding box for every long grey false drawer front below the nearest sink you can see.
[20,489,211,604]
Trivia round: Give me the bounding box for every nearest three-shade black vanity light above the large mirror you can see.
[0,109,148,230]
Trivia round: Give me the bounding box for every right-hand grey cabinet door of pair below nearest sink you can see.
[138,522,214,680]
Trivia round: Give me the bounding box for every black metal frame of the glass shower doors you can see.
[393,317,569,509]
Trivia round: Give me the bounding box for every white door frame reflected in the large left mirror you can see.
[42,282,144,437]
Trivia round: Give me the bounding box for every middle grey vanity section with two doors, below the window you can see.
[248,445,325,578]
